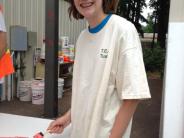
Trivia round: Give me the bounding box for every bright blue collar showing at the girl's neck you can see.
[89,14,112,33]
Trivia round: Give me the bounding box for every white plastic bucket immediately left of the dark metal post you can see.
[31,80,44,105]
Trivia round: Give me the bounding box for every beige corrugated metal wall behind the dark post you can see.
[0,0,86,47]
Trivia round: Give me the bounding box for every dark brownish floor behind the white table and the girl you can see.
[0,79,162,138]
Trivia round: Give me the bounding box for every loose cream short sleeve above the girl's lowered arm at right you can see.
[116,23,151,99]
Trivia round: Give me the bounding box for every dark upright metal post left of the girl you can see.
[44,0,59,118]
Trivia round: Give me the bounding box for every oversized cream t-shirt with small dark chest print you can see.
[71,15,151,138]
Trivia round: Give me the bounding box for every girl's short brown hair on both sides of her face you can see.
[68,0,119,20]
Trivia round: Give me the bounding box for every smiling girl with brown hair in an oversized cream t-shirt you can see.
[48,0,150,138]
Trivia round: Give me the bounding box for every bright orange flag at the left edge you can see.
[0,50,14,79]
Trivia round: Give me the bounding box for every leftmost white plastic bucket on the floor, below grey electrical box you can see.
[18,81,32,101]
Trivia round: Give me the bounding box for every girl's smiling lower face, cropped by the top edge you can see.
[74,0,104,21]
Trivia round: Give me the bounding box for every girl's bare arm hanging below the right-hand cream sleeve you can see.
[109,99,139,138]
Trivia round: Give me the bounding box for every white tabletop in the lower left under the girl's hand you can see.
[0,113,71,138]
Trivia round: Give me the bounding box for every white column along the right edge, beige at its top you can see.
[160,0,184,138]
